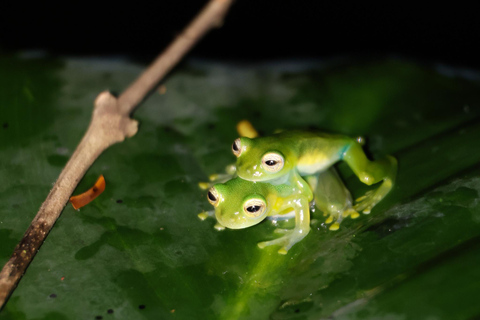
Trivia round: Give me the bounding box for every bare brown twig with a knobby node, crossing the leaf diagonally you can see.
[0,0,232,309]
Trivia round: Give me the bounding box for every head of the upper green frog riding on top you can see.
[232,137,297,181]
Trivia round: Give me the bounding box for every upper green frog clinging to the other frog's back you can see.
[232,131,397,213]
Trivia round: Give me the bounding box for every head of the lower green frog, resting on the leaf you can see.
[207,178,274,229]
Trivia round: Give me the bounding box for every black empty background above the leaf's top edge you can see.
[0,0,480,68]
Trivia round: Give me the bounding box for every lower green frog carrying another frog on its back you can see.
[199,168,359,254]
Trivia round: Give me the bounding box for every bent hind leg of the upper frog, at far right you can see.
[342,141,397,214]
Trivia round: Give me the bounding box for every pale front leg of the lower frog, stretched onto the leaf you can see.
[258,197,310,254]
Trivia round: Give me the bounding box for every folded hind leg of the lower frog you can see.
[306,167,359,231]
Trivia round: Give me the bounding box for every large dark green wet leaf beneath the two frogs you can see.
[0,56,480,319]
